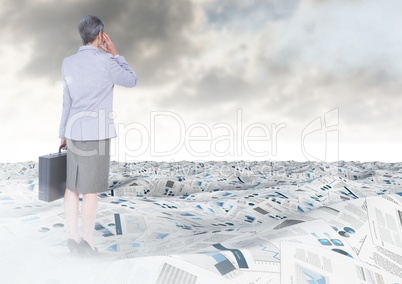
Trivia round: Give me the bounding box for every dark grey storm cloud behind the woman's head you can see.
[0,0,195,86]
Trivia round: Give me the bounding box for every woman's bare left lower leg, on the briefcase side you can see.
[64,188,80,242]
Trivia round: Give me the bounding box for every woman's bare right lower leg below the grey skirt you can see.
[81,193,98,247]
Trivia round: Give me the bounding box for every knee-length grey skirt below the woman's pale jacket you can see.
[66,139,110,194]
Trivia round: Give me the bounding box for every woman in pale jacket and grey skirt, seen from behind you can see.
[59,16,137,255]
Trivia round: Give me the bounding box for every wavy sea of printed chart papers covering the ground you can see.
[0,161,402,284]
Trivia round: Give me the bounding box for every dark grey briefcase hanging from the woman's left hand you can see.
[39,145,67,202]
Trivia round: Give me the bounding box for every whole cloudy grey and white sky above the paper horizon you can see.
[0,0,402,162]
